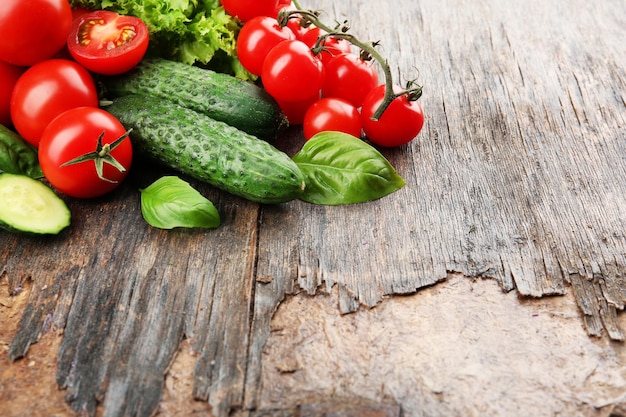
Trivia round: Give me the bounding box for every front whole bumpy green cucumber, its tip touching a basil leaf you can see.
[106,95,304,204]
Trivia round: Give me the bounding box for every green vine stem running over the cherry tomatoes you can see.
[286,0,422,120]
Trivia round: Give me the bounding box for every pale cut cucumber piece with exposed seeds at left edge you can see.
[0,173,71,234]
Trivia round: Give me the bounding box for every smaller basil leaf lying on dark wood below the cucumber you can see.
[140,176,220,229]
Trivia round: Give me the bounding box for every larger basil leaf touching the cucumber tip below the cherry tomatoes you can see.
[293,132,405,205]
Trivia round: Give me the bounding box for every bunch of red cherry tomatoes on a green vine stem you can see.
[234,0,424,147]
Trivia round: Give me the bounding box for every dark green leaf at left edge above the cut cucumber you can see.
[0,125,43,178]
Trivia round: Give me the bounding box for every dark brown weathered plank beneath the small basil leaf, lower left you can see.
[3,168,258,416]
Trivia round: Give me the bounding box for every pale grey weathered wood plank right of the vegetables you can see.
[254,1,626,311]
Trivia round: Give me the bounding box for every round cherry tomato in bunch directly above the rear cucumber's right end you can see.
[261,40,324,102]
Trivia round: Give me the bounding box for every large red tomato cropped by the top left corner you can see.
[0,0,72,66]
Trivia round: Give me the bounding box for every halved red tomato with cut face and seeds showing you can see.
[67,10,149,75]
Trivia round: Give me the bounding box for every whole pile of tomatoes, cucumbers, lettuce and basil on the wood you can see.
[0,0,424,234]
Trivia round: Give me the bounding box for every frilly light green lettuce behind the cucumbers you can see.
[70,0,254,79]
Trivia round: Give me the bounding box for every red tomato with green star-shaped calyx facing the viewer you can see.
[38,107,133,198]
